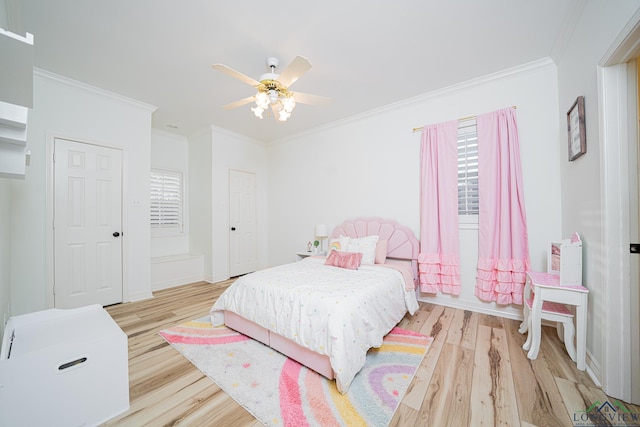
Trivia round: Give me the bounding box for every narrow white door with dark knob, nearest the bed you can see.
[229,169,257,277]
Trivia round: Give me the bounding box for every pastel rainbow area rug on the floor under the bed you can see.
[160,316,433,427]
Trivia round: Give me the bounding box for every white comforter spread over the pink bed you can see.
[211,257,418,393]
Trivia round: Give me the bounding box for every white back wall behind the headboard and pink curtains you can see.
[268,60,561,317]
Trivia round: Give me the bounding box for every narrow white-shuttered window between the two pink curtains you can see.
[458,118,479,223]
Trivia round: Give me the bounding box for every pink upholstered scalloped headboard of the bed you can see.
[329,217,420,282]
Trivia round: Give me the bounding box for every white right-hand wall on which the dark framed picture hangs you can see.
[557,0,640,394]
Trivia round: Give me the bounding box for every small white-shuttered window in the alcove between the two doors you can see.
[151,169,183,235]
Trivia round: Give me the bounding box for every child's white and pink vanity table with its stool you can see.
[519,233,589,371]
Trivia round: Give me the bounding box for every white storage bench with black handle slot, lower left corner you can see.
[0,305,129,426]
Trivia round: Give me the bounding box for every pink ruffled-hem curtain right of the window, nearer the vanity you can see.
[475,108,530,304]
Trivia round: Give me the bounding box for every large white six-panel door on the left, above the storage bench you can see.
[53,138,122,308]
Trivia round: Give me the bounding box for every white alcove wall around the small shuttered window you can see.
[151,129,189,258]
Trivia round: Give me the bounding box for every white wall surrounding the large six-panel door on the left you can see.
[11,70,153,315]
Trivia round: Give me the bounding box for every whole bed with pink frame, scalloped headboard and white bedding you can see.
[211,218,419,393]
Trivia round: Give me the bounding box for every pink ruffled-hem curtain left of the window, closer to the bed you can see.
[418,121,460,295]
